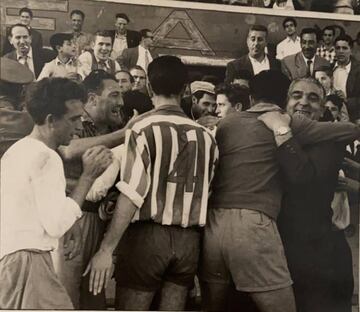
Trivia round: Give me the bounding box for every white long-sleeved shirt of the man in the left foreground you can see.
[0,137,82,259]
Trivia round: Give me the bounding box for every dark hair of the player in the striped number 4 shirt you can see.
[148,55,188,97]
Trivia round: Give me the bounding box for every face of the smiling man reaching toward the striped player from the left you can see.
[92,79,124,127]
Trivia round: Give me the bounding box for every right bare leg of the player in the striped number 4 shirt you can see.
[159,282,189,311]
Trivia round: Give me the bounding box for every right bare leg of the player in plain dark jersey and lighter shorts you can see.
[251,286,296,312]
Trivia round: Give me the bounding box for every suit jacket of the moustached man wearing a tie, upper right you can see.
[281,52,330,80]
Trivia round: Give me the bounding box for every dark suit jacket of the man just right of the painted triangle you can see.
[225,54,280,83]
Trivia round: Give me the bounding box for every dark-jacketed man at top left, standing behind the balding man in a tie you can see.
[1,8,43,55]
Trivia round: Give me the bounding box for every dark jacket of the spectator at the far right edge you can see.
[346,58,360,121]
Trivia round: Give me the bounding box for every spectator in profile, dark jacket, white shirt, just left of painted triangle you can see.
[117,29,158,72]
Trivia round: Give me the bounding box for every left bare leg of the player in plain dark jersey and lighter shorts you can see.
[200,282,229,311]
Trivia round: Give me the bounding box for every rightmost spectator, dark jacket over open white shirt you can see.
[333,35,360,121]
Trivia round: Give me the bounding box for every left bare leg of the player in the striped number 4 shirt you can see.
[115,287,155,311]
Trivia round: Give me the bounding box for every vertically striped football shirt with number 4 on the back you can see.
[117,106,218,227]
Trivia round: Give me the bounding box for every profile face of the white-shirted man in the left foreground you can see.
[54,100,84,146]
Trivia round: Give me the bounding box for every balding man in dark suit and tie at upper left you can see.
[4,24,45,79]
